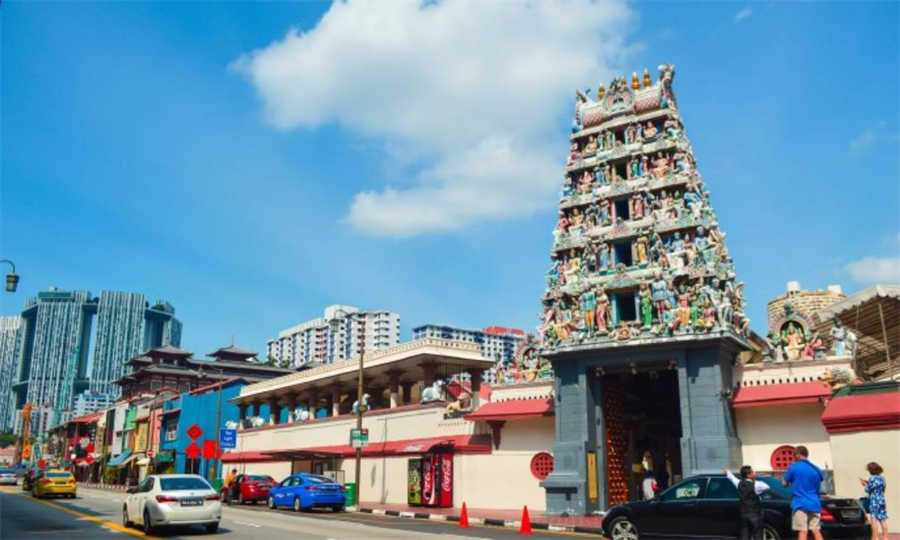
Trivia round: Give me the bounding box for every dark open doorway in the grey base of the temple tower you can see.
[603,369,682,507]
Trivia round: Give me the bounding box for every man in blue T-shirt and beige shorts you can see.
[782,446,822,540]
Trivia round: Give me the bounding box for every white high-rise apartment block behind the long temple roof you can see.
[267,305,400,367]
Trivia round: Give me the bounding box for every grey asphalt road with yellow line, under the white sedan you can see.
[0,487,598,540]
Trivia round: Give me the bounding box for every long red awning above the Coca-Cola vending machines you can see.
[264,435,491,459]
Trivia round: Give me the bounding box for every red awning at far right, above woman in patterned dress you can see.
[822,392,900,433]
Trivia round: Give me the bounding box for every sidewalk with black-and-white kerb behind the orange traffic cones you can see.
[359,501,603,534]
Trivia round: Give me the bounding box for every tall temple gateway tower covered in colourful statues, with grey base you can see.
[541,65,749,515]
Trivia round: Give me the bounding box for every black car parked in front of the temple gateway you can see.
[603,474,871,540]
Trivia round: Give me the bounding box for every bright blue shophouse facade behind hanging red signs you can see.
[159,379,269,480]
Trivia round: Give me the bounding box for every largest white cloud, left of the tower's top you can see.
[232,0,636,236]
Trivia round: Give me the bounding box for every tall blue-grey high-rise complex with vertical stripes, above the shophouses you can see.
[10,288,182,433]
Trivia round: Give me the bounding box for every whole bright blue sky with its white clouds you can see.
[0,1,900,353]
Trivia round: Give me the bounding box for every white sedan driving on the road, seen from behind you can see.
[122,474,222,535]
